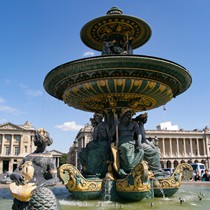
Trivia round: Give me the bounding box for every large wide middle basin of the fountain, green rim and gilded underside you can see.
[44,55,192,112]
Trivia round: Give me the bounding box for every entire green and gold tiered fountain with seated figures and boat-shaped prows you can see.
[44,7,192,201]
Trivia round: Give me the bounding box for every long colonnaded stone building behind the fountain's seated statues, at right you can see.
[68,125,210,168]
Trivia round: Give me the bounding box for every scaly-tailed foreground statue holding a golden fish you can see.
[10,129,60,210]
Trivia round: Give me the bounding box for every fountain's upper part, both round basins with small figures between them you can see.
[44,7,192,112]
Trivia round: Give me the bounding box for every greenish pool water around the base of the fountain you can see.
[0,182,210,210]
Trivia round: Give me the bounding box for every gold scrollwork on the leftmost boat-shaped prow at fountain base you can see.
[59,164,102,192]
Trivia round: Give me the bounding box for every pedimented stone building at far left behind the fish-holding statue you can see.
[0,121,63,174]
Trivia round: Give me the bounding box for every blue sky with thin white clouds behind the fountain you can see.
[0,0,210,152]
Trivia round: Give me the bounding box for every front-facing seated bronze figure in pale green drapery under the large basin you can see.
[112,109,144,177]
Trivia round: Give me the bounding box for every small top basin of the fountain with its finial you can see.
[80,7,151,51]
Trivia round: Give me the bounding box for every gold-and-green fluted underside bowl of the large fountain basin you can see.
[63,78,173,112]
